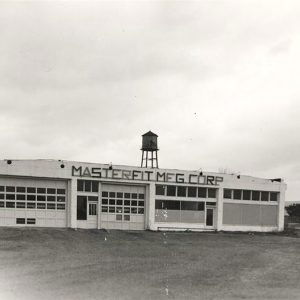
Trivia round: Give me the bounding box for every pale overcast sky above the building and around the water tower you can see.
[0,0,300,201]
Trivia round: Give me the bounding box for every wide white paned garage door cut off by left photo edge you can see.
[0,178,67,227]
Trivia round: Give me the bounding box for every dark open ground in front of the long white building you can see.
[0,228,300,300]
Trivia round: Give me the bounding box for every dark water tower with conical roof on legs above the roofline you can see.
[141,131,158,168]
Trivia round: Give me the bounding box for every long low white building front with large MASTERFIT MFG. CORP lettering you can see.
[0,160,286,232]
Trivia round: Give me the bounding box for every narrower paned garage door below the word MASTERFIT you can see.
[100,184,145,230]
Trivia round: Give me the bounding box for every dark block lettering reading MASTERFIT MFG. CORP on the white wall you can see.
[72,166,223,185]
